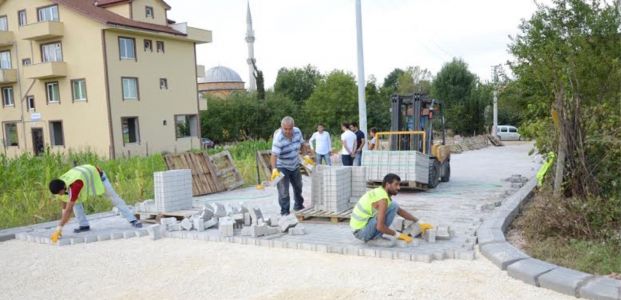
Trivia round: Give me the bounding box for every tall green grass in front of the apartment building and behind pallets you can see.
[0,141,271,229]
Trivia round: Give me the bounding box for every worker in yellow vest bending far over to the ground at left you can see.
[49,165,142,243]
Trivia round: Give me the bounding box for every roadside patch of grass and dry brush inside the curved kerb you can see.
[513,189,621,276]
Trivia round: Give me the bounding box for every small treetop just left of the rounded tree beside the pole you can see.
[274,65,322,105]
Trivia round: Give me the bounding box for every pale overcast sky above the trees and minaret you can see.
[166,0,536,88]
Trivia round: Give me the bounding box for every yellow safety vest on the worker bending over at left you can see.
[59,165,106,202]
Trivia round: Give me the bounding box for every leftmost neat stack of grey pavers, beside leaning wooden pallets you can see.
[153,169,192,212]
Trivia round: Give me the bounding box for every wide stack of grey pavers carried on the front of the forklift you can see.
[362,151,429,183]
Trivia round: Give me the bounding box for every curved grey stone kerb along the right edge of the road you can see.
[477,176,621,299]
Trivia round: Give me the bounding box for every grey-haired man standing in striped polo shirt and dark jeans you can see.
[270,116,304,216]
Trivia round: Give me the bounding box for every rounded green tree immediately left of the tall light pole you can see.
[303,70,358,134]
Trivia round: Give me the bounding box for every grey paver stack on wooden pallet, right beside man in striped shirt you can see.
[296,166,367,223]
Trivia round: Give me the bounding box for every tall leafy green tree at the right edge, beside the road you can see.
[509,0,621,199]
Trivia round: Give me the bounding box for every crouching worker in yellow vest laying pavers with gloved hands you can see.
[349,173,431,247]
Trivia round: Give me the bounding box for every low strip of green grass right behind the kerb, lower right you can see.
[525,238,621,275]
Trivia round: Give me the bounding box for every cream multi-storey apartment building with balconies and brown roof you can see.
[0,0,211,158]
